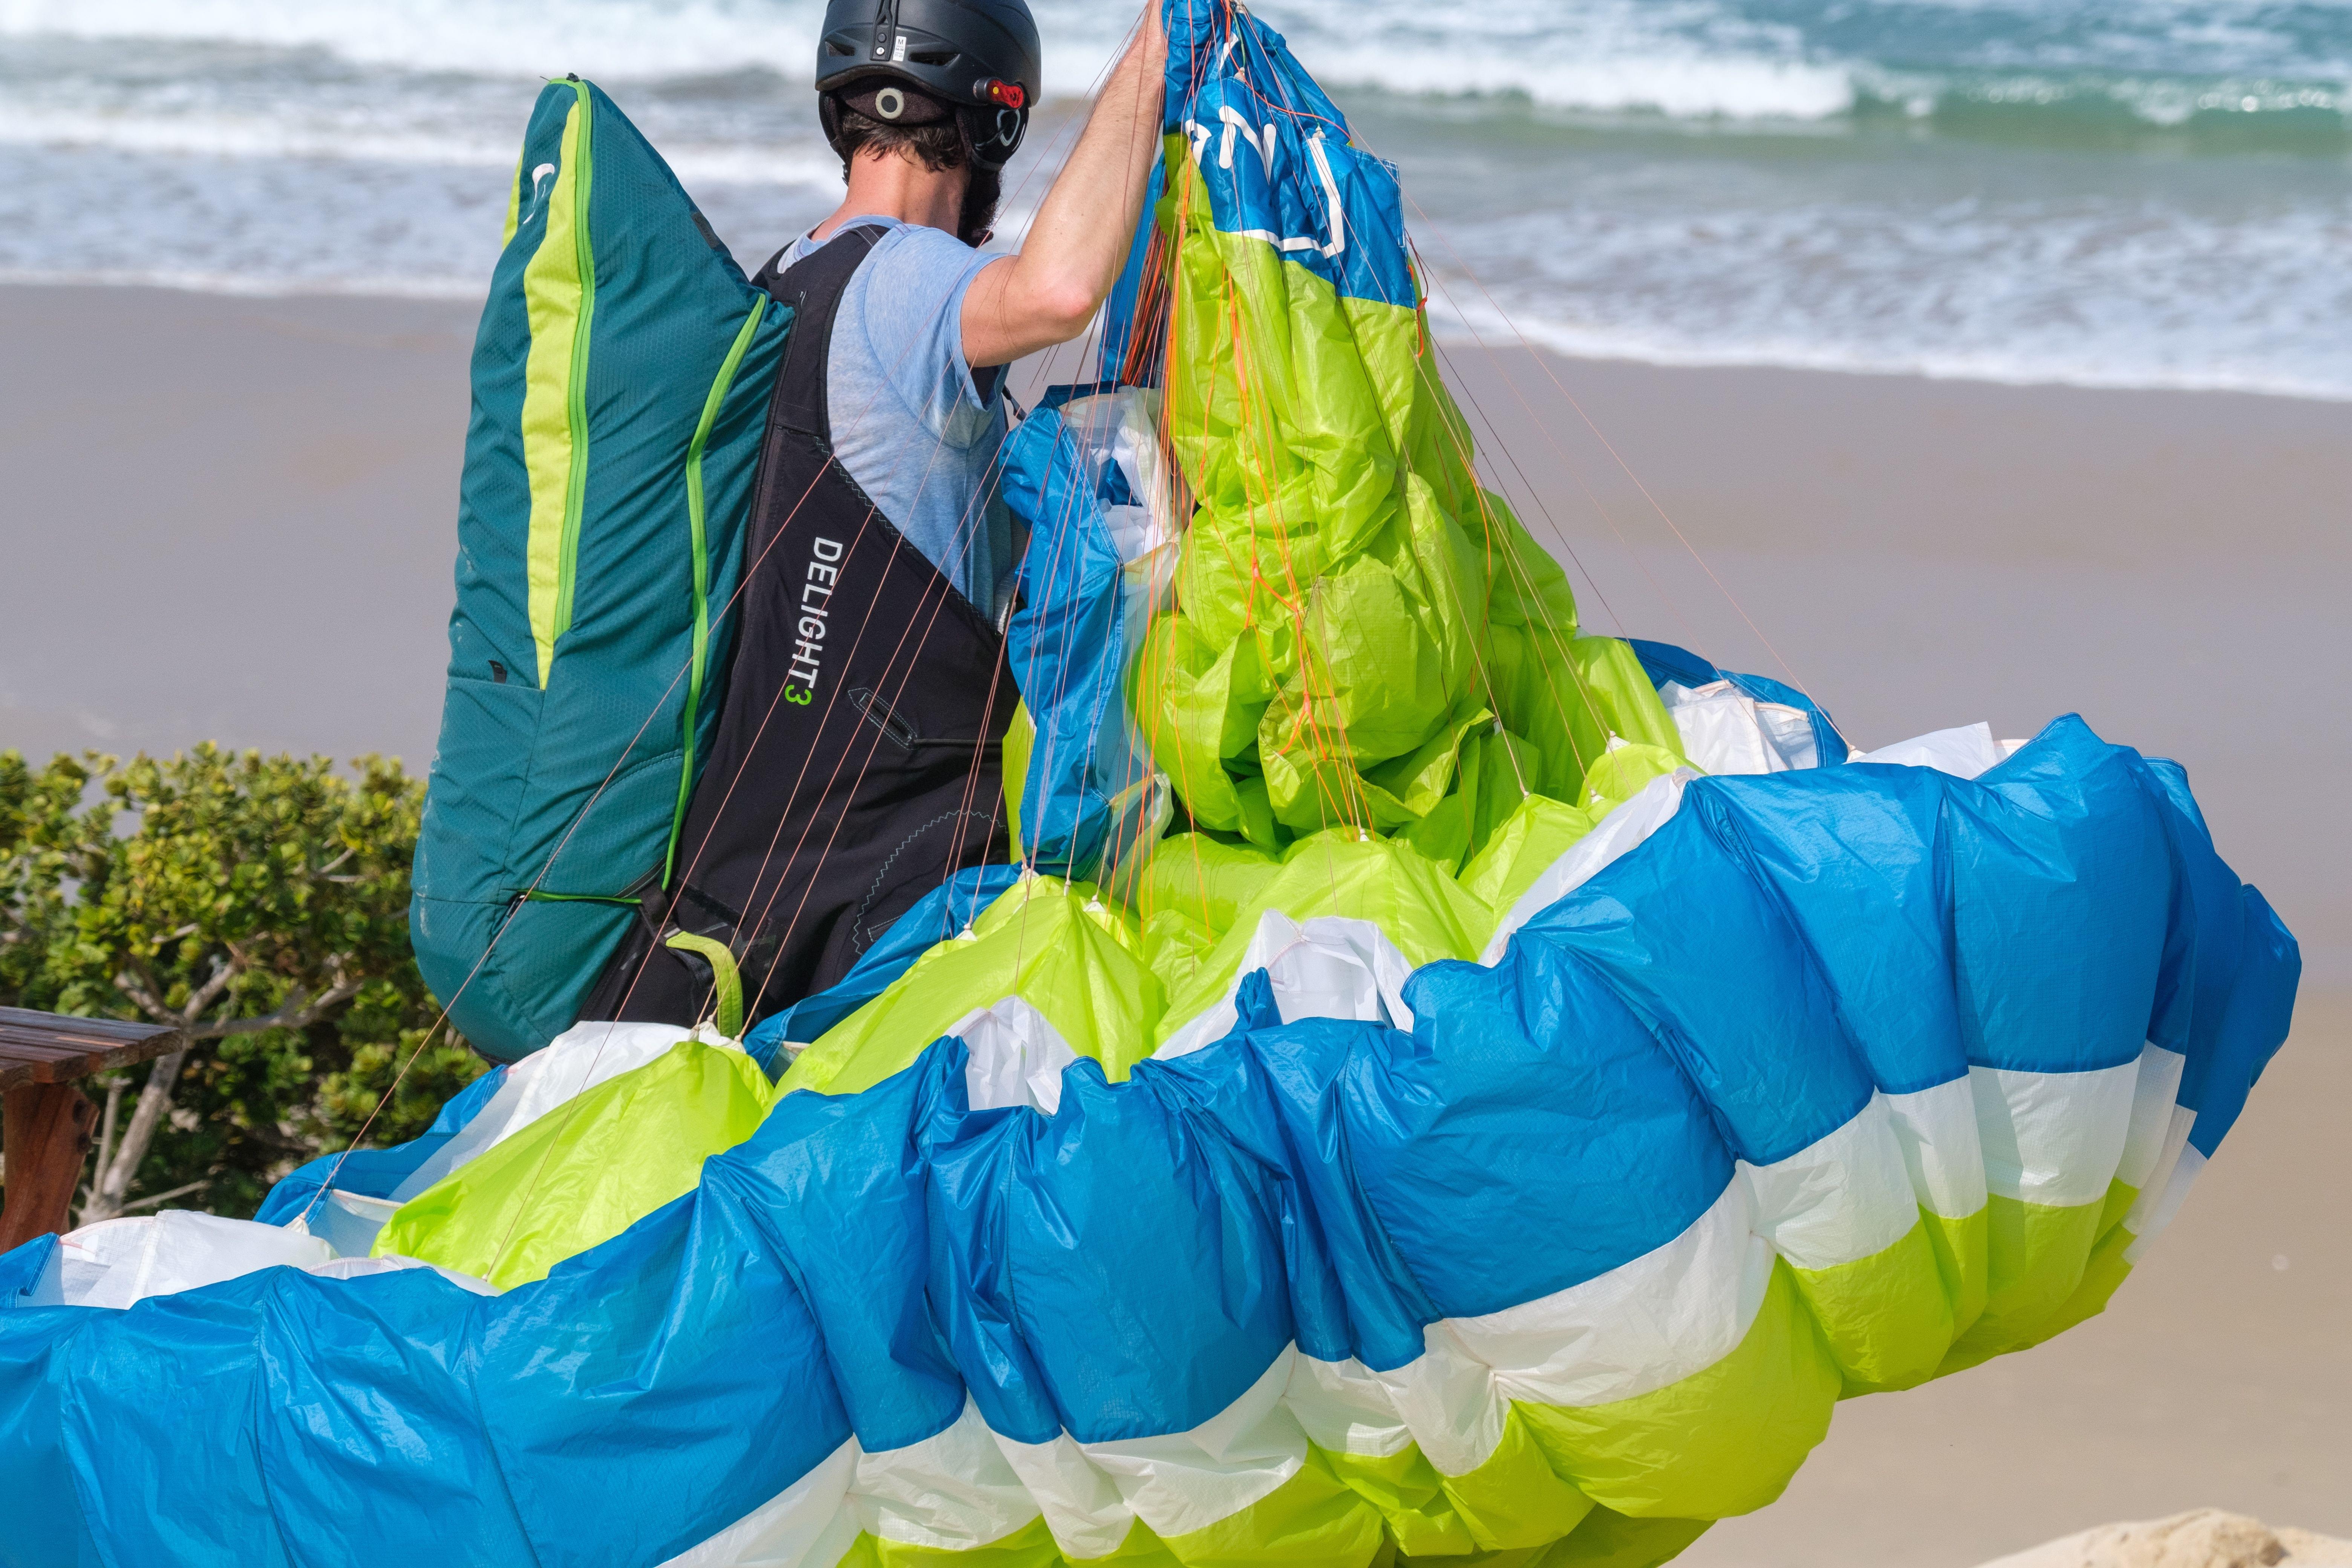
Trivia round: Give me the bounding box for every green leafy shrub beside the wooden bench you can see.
[0,745,484,1222]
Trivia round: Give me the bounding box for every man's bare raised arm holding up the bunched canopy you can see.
[964,0,1169,369]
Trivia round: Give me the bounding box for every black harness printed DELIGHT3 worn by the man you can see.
[581,226,1018,1025]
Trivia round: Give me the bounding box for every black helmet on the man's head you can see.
[816,0,1044,169]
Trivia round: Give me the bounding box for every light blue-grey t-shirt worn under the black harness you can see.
[778,219,1014,621]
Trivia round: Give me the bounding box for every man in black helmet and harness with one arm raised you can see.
[586,0,1167,1023]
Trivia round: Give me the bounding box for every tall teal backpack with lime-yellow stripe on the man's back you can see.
[409,78,790,1060]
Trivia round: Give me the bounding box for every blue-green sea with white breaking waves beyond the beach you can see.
[0,0,2352,397]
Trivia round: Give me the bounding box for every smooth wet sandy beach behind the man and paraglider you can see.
[0,287,2352,1568]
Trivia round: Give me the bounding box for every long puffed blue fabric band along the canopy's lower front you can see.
[0,719,2298,1568]
